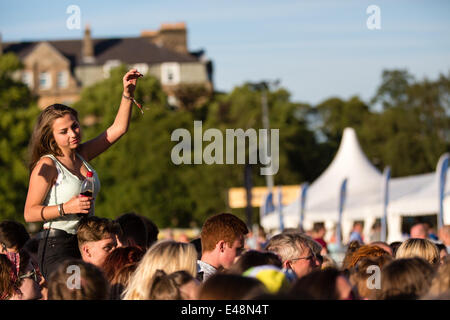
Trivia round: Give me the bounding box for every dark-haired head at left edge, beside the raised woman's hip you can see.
[0,220,30,253]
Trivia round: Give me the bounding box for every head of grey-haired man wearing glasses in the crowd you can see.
[267,232,322,278]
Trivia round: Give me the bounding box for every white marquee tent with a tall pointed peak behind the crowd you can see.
[261,128,450,242]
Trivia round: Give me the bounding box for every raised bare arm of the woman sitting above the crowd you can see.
[79,69,142,161]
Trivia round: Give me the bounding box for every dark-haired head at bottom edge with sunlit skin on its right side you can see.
[289,268,358,300]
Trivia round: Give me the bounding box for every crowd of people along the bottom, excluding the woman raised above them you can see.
[0,212,450,300]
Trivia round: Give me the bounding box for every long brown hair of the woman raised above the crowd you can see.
[29,104,78,173]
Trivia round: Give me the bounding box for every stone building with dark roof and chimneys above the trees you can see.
[0,23,213,108]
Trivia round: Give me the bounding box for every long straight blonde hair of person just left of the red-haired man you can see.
[122,240,197,300]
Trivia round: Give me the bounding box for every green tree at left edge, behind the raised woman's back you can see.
[0,54,39,222]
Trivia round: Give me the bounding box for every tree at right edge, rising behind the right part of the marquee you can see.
[364,70,450,176]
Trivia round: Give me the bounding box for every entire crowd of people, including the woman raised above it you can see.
[0,69,450,300]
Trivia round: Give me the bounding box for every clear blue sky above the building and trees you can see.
[0,0,450,104]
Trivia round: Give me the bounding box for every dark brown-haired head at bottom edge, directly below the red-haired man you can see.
[198,272,268,300]
